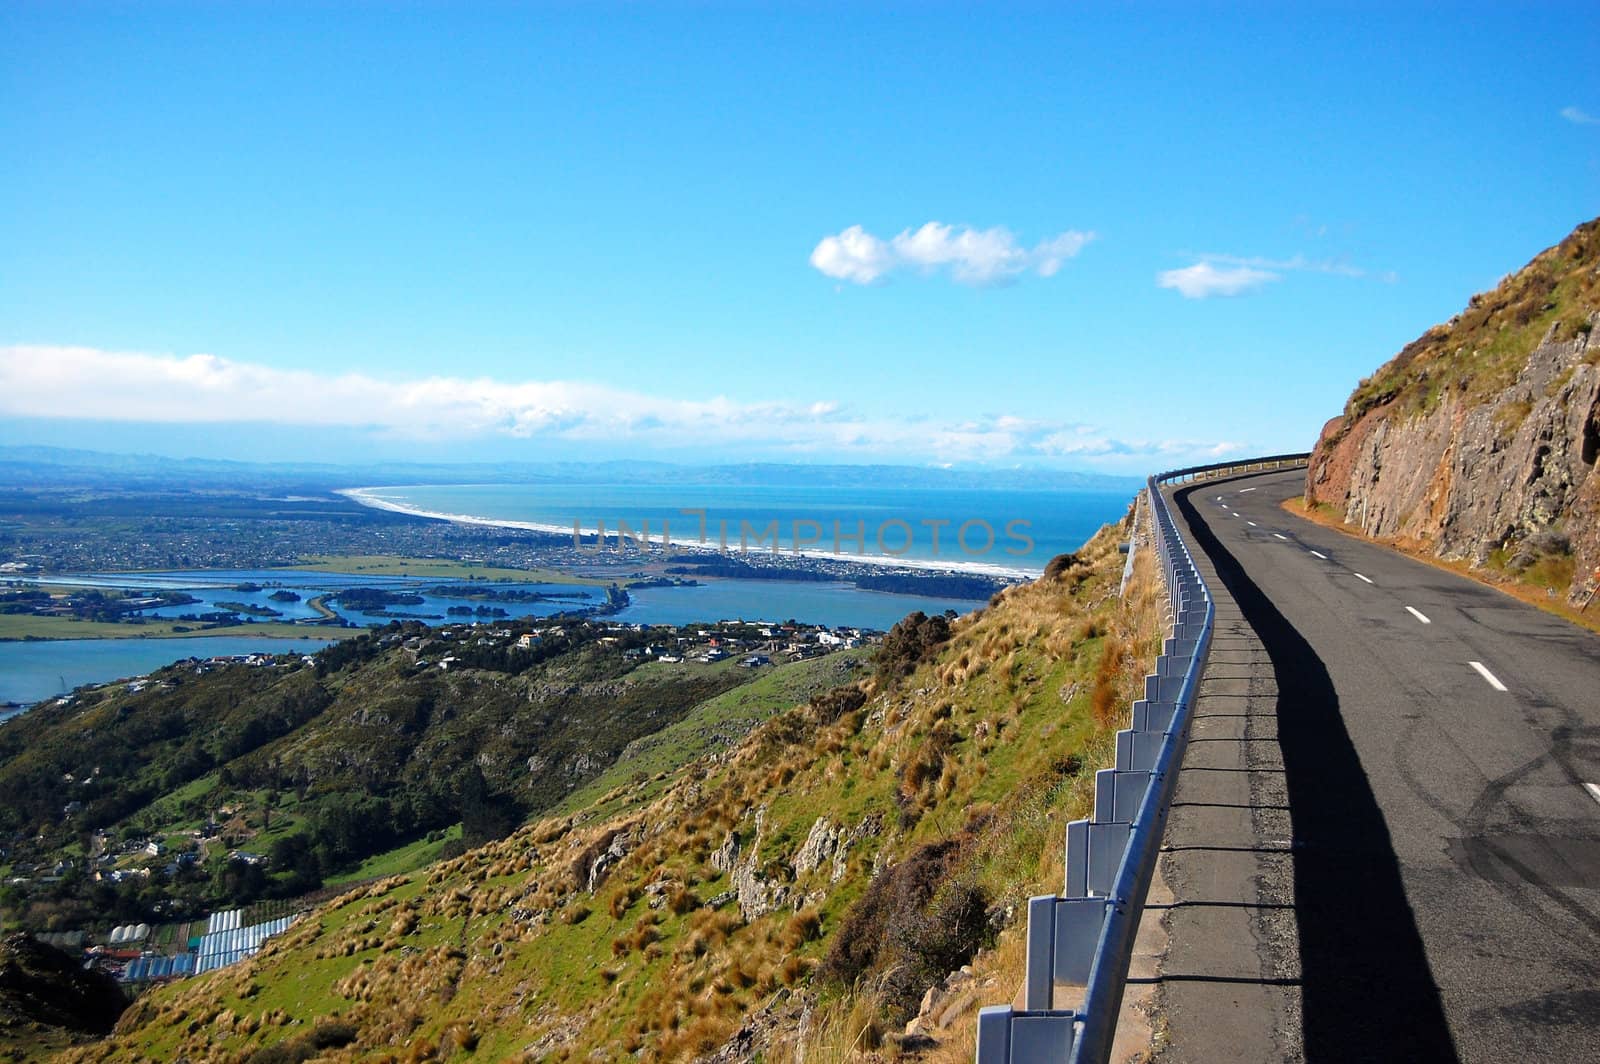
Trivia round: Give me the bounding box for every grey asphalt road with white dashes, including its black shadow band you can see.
[1174,470,1600,1061]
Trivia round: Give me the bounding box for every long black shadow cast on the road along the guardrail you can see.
[1174,488,1458,1064]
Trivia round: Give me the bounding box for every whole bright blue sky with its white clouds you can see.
[0,2,1600,472]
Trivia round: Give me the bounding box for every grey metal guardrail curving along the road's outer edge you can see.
[976,453,1309,1064]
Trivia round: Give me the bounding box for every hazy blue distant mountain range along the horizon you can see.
[0,446,1141,493]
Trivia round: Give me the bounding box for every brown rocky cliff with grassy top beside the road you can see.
[1306,219,1600,602]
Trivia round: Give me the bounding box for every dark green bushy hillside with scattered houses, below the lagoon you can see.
[0,621,866,931]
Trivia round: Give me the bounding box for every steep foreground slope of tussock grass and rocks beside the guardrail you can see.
[50,512,1162,1064]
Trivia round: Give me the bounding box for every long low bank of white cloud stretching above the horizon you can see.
[0,346,1232,472]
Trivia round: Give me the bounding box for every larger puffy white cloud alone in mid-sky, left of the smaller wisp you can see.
[811,221,1094,285]
